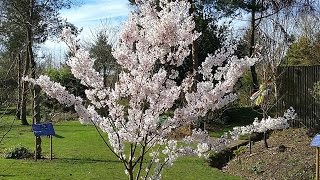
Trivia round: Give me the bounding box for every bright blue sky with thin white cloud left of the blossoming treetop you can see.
[42,0,130,63]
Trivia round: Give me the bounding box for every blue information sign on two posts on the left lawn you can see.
[32,123,56,160]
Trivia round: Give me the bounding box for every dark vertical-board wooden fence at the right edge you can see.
[277,66,320,128]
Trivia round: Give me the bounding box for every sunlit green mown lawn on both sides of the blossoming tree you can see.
[0,116,240,180]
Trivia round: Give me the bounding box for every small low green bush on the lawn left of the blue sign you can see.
[4,144,33,159]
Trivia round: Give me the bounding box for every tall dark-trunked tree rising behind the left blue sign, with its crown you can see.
[0,0,78,158]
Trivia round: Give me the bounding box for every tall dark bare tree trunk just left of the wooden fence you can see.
[249,0,259,92]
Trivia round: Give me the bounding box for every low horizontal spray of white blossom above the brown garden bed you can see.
[224,107,297,140]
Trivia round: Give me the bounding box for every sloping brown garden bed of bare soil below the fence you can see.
[224,129,315,180]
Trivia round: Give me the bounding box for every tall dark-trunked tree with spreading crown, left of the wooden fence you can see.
[212,0,311,92]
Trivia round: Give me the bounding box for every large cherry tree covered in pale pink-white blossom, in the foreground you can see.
[25,0,256,180]
